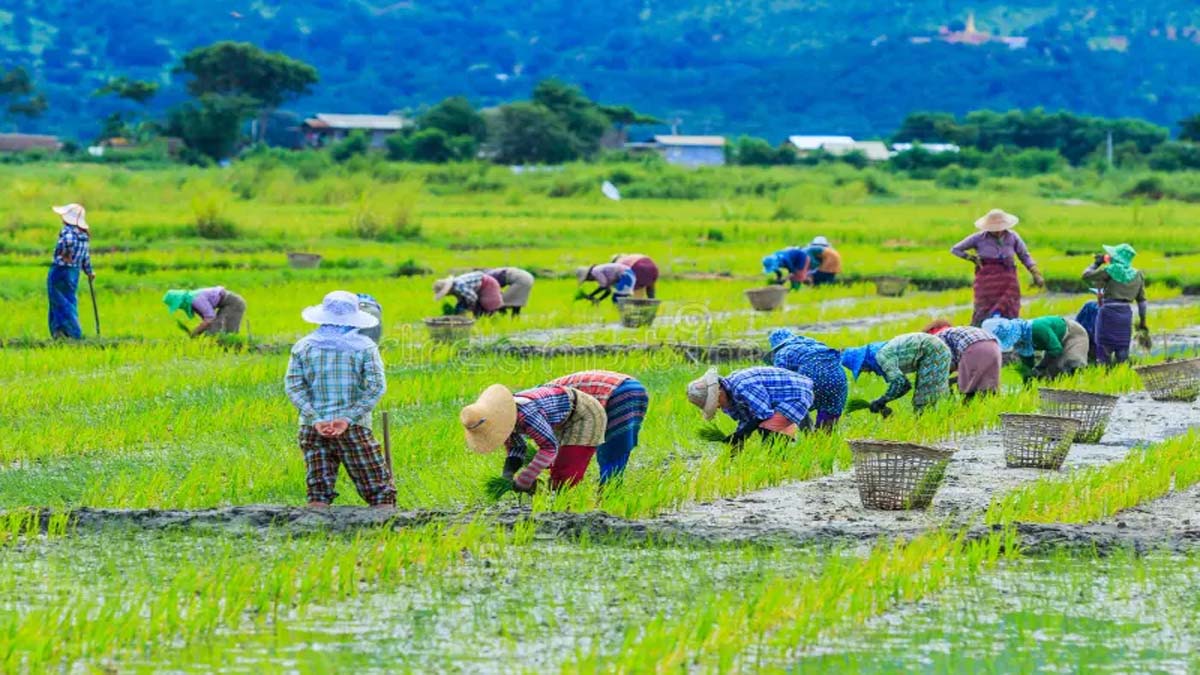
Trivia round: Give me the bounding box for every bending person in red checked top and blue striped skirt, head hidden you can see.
[547,370,650,485]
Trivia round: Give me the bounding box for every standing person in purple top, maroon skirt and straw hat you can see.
[950,209,1045,325]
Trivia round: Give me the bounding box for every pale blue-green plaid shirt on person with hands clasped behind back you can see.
[284,346,388,429]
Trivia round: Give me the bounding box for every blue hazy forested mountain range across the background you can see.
[0,0,1200,142]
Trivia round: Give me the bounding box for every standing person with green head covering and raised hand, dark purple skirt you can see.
[1084,244,1147,364]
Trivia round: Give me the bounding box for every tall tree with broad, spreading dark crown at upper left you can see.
[175,42,318,139]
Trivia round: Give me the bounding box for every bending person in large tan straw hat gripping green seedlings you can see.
[458,384,607,494]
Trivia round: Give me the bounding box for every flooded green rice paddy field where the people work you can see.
[0,157,1200,673]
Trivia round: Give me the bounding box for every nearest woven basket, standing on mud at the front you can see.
[850,441,954,510]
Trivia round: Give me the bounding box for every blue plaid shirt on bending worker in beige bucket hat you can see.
[720,366,812,431]
